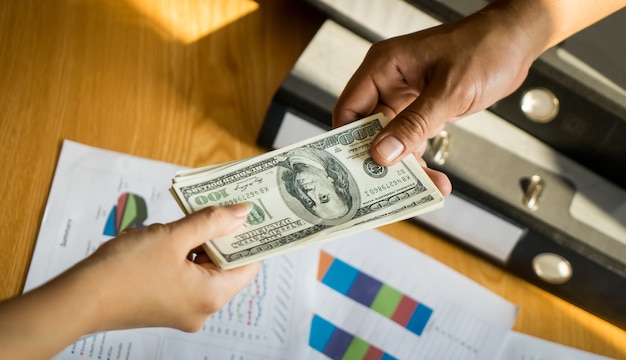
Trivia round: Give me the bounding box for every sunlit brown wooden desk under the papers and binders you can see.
[0,0,626,358]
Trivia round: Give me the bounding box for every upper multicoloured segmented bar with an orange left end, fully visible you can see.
[317,251,433,336]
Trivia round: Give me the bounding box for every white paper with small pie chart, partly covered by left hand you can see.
[25,141,316,360]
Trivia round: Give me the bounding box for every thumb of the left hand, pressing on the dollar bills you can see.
[170,203,251,254]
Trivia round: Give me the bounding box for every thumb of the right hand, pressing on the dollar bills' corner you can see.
[371,90,455,166]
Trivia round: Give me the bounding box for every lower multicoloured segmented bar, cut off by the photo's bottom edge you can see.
[309,314,395,360]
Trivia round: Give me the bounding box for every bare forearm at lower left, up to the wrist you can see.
[0,260,100,359]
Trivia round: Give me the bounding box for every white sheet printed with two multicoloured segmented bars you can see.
[309,232,515,359]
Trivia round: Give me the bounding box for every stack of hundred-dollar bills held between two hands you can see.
[171,114,443,269]
